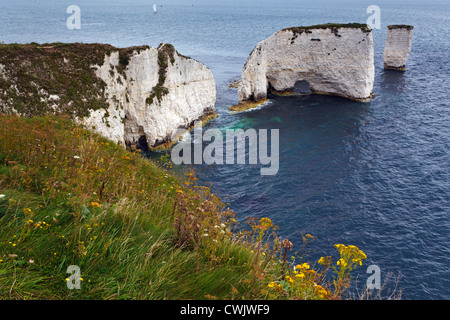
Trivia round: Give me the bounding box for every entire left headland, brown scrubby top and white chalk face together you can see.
[0,44,216,149]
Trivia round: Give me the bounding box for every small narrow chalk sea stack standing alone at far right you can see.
[383,25,414,71]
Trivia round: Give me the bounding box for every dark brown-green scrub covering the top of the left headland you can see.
[0,43,149,117]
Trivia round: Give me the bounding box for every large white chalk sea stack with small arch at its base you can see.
[238,24,375,103]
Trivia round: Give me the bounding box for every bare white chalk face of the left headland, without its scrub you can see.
[87,44,216,147]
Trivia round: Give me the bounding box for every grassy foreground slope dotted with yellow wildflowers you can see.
[0,114,384,299]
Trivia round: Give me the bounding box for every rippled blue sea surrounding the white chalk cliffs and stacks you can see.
[0,0,450,299]
